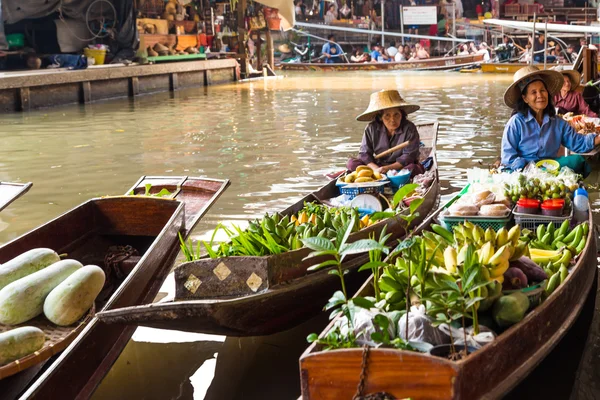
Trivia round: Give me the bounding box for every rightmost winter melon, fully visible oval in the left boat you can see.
[44,265,105,326]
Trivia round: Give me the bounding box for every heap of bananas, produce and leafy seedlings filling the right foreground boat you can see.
[310,221,589,359]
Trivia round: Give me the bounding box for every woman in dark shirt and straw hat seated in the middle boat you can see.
[347,90,425,176]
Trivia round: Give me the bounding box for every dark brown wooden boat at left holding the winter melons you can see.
[0,177,229,399]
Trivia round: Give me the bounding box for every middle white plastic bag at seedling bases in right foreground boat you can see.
[398,304,450,346]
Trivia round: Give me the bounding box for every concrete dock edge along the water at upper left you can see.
[0,59,238,113]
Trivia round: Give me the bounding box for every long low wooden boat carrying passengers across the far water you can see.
[279,54,483,71]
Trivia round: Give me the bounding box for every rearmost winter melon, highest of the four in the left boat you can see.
[0,248,60,289]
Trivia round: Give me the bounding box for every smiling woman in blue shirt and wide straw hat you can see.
[502,66,600,175]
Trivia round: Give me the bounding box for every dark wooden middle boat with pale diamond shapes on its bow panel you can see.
[98,122,439,336]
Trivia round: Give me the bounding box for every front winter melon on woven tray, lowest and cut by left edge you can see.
[0,326,46,365]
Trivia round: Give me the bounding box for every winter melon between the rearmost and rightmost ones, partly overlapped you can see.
[0,260,83,325]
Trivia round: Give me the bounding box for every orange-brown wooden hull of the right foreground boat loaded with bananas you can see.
[300,209,597,400]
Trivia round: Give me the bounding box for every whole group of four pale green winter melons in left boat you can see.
[0,248,105,365]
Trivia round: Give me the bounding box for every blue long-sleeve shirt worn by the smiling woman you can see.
[502,112,596,169]
